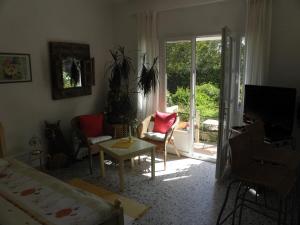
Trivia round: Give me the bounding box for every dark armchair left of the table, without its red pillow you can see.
[71,116,112,174]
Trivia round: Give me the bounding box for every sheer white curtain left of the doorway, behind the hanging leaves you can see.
[137,12,159,119]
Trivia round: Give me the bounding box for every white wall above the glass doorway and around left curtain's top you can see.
[113,0,245,57]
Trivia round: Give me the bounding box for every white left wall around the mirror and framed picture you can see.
[0,0,113,155]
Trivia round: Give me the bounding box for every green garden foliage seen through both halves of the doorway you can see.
[166,41,221,121]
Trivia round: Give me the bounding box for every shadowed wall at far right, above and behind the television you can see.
[268,0,300,151]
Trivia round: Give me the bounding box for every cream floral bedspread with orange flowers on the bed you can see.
[0,159,113,225]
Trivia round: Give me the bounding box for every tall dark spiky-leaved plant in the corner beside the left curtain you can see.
[105,47,158,124]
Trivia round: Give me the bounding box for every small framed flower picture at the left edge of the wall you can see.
[0,53,32,83]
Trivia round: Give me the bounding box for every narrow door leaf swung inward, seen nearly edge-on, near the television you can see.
[216,27,233,179]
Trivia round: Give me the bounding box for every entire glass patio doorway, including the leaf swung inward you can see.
[162,27,236,176]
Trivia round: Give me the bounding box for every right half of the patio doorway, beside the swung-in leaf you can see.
[193,35,221,161]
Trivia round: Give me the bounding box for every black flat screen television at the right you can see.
[244,85,296,141]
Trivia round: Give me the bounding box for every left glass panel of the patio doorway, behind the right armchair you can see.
[165,40,192,152]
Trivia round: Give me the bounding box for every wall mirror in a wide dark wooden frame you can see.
[49,42,95,99]
